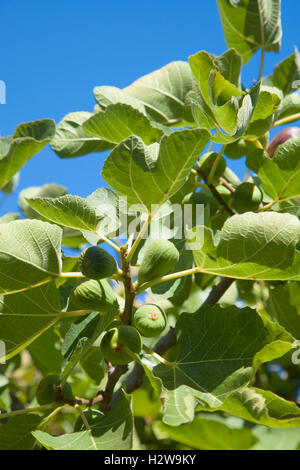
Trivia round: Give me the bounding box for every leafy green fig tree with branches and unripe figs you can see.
[0,0,300,451]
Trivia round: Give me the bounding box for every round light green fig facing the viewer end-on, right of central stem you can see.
[133,304,167,338]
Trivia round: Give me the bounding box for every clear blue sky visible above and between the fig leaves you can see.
[0,0,300,215]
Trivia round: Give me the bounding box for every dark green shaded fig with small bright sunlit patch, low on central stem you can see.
[100,325,142,365]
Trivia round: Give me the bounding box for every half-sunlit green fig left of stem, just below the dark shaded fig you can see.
[69,279,117,312]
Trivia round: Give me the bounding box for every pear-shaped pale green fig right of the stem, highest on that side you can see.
[138,239,179,284]
